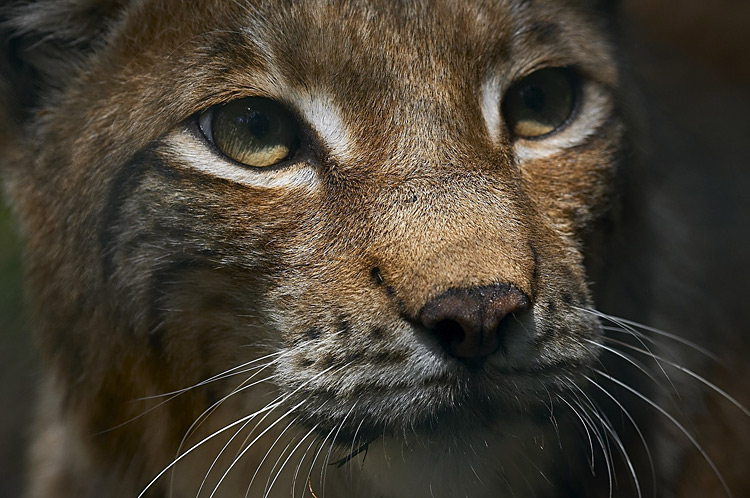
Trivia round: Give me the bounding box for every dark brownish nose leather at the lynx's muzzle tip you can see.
[419,284,529,360]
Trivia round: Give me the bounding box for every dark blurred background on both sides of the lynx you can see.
[0,0,750,498]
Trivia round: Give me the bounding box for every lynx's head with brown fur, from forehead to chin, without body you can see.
[6,0,624,496]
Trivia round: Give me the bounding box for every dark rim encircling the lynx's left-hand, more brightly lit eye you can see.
[195,95,313,171]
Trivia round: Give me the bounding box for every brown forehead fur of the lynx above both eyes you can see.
[2,0,614,177]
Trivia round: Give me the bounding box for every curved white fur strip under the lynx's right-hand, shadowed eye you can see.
[513,82,612,163]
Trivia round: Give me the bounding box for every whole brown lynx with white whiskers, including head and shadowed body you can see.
[0,0,748,498]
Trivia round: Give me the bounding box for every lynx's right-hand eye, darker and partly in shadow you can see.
[503,68,577,138]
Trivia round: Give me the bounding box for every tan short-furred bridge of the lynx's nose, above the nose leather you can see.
[372,169,535,313]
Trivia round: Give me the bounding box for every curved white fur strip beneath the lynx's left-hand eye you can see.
[163,129,319,191]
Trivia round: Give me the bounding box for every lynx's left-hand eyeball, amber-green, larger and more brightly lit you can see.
[198,97,299,168]
